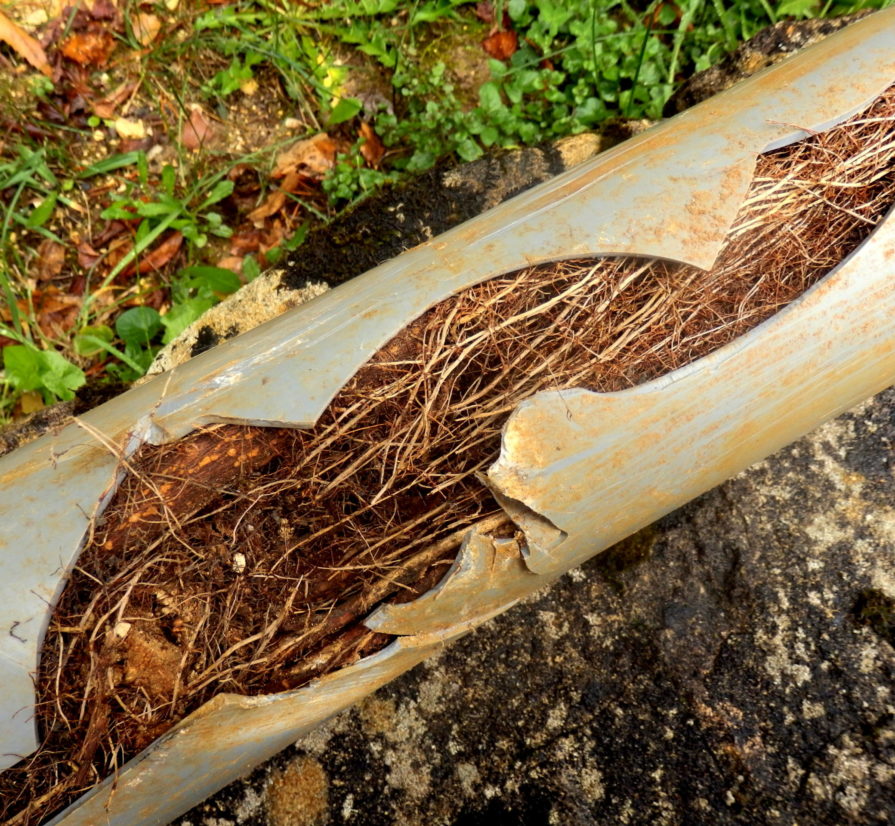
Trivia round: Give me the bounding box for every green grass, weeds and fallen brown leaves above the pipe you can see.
[0,0,886,419]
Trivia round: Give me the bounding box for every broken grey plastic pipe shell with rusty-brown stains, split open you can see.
[0,9,895,826]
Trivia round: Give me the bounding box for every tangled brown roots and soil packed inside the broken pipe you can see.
[0,88,895,824]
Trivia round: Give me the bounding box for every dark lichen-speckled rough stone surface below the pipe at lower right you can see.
[178,391,895,826]
